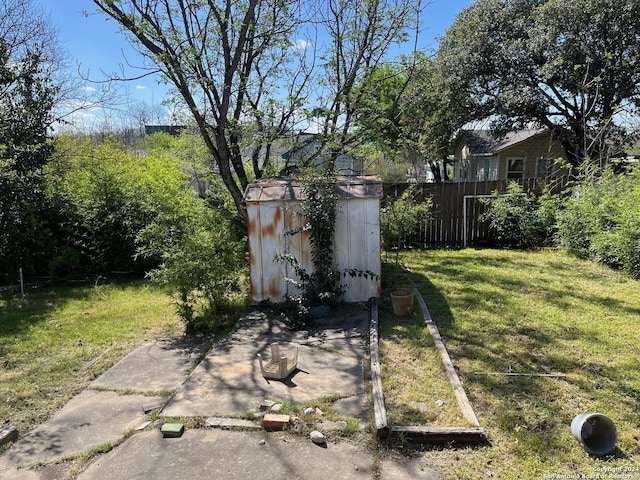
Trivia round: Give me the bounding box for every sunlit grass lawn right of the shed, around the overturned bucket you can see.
[381,249,640,479]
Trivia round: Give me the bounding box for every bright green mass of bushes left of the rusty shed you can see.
[49,136,246,330]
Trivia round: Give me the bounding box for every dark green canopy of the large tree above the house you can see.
[437,0,640,172]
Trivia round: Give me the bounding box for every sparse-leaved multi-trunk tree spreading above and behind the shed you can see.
[94,0,420,227]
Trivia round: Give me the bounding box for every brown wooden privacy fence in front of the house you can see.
[383,177,568,248]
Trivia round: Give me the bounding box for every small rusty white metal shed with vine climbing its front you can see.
[244,175,382,302]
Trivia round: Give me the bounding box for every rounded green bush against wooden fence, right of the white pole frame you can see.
[481,182,558,248]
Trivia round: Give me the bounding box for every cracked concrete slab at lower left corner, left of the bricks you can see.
[0,390,162,473]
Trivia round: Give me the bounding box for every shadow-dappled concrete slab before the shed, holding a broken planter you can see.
[162,309,368,417]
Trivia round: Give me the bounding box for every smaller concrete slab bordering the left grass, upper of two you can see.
[90,340,211,392]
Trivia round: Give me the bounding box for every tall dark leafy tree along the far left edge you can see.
[0,41,58,285]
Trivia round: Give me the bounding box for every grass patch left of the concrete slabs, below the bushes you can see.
[0,282,183,435]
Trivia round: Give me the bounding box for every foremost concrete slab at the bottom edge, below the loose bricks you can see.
[78,430,372,480]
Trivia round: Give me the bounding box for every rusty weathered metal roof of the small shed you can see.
[244,175,383,202]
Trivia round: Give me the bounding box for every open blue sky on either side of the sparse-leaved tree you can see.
[33,0,473,126]
